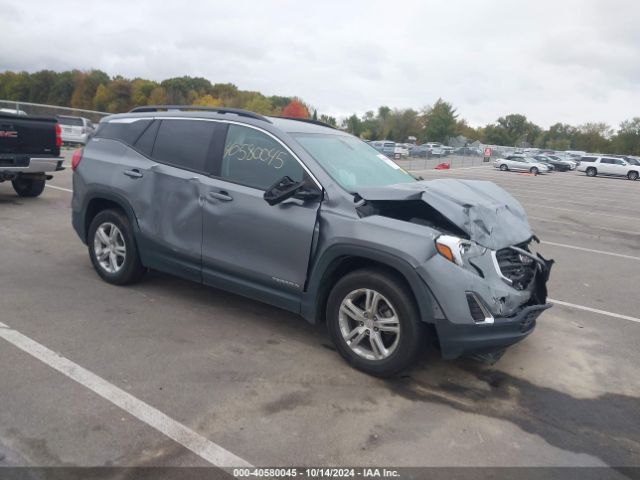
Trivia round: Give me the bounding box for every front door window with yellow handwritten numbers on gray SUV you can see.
[220,125,305,190]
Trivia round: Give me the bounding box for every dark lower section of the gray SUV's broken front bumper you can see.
[435,303,551,359]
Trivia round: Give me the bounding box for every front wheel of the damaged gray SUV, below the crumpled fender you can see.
[326,269,426,377]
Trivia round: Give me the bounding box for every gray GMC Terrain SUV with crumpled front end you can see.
[72,106,552,376]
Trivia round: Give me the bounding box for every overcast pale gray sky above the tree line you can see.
[0,0,640,127]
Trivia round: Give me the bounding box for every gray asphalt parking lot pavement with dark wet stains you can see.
[0,153,640,467]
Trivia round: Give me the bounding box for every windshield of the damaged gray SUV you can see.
[293,133,416,193]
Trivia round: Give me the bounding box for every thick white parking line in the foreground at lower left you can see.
[0,324,252,468]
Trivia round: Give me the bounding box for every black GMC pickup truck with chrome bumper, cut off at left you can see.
[0,112,64,197]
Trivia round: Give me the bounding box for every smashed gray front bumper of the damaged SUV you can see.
[417,240,553,359]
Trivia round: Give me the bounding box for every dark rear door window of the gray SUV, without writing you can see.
[151,120,222,173]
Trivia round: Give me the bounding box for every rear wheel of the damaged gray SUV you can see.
[87,210,146,285]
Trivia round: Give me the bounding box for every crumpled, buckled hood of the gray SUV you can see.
[357,178,533,250]
